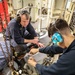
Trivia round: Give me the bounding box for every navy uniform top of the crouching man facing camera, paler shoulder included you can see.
[5,19,37,48]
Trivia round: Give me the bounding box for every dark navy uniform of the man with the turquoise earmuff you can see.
[36,40,75,75]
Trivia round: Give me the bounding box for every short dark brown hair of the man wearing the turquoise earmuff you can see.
[48,19,69,37]
